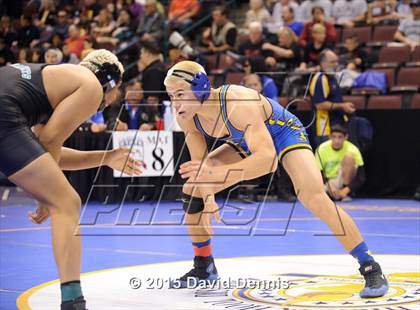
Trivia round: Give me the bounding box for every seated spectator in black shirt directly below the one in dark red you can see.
[300,24,332,71]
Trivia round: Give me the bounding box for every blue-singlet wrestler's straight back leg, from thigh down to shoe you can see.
[282,149,389,298]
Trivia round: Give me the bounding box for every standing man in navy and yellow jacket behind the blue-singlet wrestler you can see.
[309,49,355,145]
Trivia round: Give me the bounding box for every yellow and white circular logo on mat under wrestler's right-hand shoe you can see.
[232,272,420,310]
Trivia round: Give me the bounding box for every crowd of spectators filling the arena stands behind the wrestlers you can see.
[0,0,420,136]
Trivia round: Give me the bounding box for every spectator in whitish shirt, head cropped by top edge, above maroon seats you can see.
[332,0,368,28]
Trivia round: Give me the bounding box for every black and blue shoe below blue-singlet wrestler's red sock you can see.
[170,256,219,288]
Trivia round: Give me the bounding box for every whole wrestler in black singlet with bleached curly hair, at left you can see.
[0,50,140,309]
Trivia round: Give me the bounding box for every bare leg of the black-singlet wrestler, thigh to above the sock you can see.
[9,153,81,283]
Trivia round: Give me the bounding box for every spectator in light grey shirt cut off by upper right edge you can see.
[394,3,420,50]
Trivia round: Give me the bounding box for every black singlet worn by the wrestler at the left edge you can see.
[0,64,53,176]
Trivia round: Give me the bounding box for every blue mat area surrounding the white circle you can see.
[0,199,420,309]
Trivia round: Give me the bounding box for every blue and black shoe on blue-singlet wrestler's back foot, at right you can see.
[359,262,389,298]
